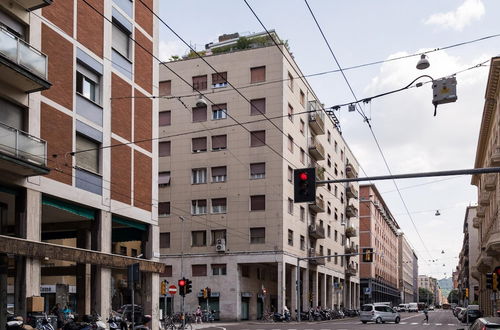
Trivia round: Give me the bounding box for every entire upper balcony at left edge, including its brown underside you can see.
[0,26,51,93]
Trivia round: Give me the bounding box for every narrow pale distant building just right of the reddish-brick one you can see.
[398,234,417,303]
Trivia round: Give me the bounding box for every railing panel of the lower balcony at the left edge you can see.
[0,123,47,166]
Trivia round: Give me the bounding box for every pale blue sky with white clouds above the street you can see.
[159,0,500,278]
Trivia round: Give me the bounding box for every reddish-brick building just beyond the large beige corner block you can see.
[359,184,401,305]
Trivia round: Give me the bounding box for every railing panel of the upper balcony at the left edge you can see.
[0,25,48,80]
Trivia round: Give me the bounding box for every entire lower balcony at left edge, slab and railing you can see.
[0,123,49,177]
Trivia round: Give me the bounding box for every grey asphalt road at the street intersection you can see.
[193,310,465,330]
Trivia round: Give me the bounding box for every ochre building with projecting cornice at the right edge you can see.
[472,57,500,315]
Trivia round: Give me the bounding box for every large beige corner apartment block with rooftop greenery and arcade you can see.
[159,31,359,320]
